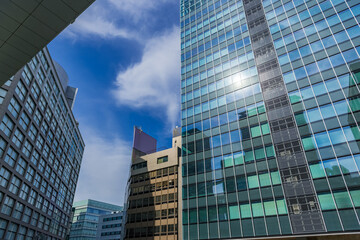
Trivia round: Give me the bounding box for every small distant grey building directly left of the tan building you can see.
[96,211,124,240]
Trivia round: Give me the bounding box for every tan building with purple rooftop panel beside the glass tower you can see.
[125,128,181,240]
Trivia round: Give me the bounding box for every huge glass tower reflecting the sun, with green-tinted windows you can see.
[181,0,360,239]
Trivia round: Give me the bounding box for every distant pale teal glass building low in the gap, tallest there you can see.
[67,199,123,240]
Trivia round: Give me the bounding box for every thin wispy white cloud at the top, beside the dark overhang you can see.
[64,0,175,42]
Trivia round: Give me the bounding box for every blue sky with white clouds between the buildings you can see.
[48,0,180,204]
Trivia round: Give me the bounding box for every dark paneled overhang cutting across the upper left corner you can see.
[0,0,95,86]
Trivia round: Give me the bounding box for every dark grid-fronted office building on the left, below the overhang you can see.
[0,48,84,239]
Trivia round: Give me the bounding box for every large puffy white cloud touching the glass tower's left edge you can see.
[113,27,180,127]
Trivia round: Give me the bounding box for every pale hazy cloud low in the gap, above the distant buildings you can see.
[74,127,131,205]
